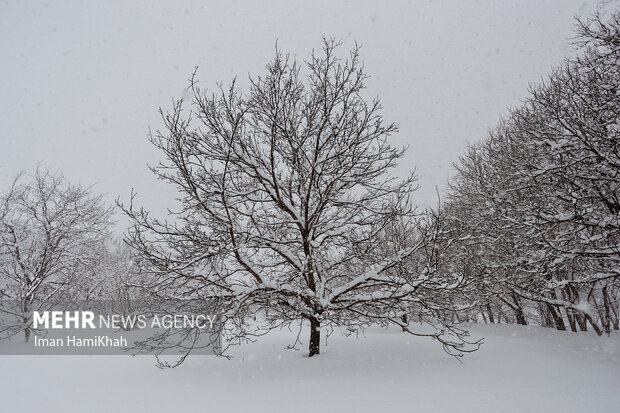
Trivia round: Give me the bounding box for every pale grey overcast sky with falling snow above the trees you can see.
[0,0,618,225]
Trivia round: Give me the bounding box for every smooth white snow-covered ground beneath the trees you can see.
[0,325,620,413]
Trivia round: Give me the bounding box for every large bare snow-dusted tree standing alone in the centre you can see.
[124,40,480,356]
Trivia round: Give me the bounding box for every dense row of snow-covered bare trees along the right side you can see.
[446,12,620,335]
